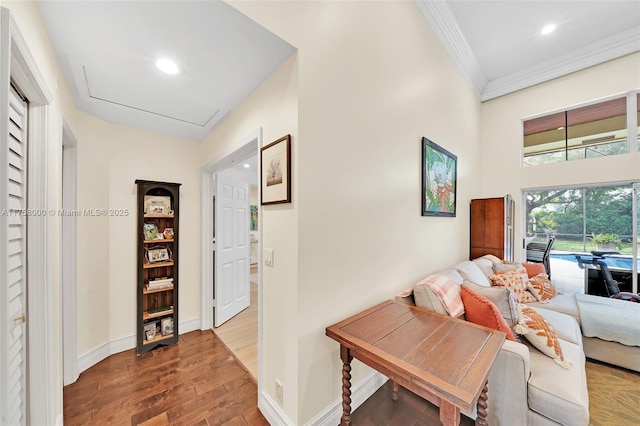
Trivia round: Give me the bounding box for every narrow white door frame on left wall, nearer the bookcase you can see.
[61,119,80,386]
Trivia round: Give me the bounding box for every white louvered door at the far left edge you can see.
[0,82,27,425]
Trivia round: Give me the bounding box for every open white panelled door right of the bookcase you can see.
[214,171,250,327]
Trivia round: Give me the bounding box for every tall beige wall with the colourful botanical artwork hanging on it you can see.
[232,1,480,424]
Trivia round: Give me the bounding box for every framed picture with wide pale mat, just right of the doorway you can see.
[260,135,291,206]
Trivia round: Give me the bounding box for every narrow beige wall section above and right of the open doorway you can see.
[200,53,299,418]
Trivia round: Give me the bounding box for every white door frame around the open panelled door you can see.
[200,127,262,376]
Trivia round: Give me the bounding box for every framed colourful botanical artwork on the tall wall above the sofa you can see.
[422,138,458,217]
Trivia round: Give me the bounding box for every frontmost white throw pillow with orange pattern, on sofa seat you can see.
[515,303,571,369]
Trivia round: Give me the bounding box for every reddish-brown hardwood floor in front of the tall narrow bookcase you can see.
[64,330,268,426]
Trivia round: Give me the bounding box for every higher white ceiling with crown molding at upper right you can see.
[416,0,640,101]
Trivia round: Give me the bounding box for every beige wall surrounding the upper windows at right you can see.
[478,53,640,259]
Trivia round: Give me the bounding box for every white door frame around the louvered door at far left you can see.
[0,8,55,424]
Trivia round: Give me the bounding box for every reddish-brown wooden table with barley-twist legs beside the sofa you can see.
[326,300,505,426]
